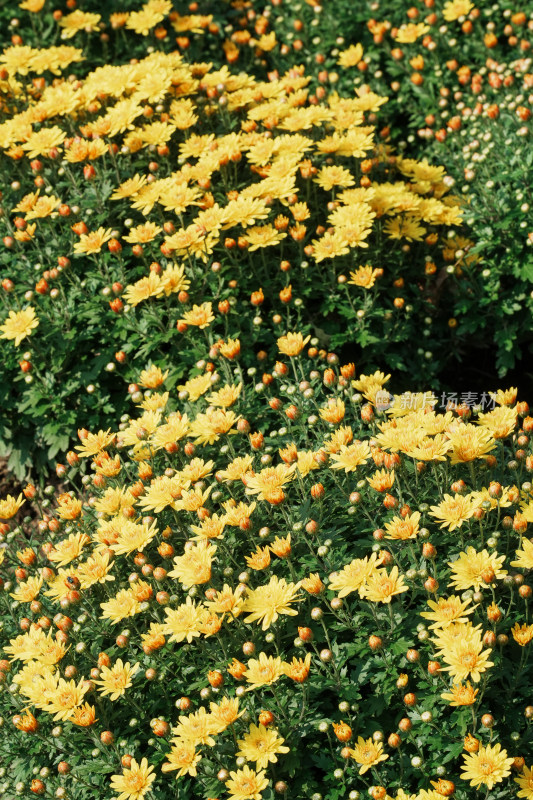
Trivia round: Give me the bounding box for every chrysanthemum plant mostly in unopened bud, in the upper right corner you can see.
[238,0,533,376]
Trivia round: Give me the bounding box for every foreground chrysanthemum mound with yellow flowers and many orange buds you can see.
[0,340,533,800]
